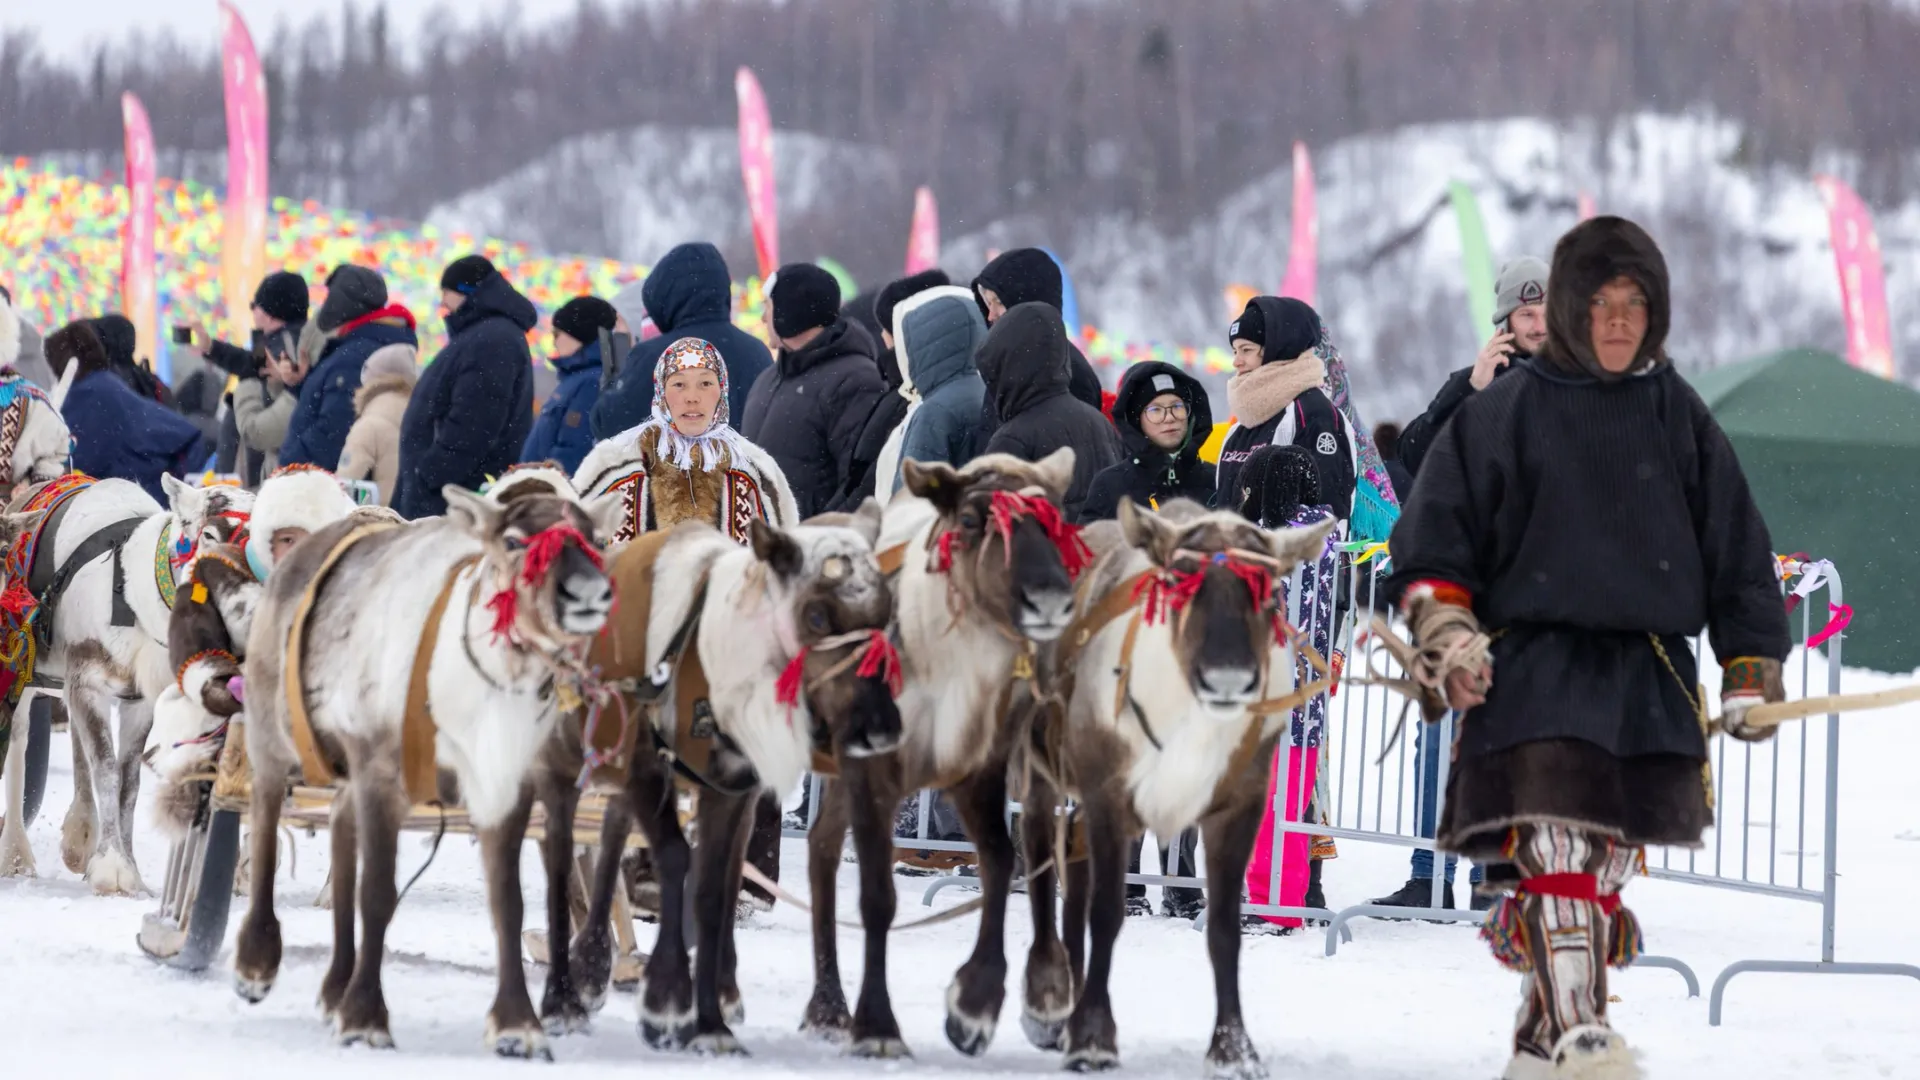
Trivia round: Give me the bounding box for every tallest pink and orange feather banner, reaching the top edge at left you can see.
[221,0,267,340]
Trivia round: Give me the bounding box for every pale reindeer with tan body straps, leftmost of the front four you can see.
[234,486,612,1057]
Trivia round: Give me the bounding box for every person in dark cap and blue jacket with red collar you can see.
[278,263,420,473]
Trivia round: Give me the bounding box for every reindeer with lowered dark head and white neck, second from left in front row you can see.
[549,500,900,1053]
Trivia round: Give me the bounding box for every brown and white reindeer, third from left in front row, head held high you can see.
[801,450,1091,1057]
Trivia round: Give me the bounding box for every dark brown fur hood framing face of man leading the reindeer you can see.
[1540,217,1672,382]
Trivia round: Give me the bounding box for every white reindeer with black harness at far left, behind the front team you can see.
[0,477,253,894]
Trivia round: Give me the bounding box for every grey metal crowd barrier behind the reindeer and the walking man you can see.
[787,544,1920,1026]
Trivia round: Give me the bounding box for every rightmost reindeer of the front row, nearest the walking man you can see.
[1023,500,1332,1080]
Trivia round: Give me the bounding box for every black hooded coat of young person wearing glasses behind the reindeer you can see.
[1081,359,1213,521]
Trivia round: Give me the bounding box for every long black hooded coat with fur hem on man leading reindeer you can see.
[1386,217,1788,861]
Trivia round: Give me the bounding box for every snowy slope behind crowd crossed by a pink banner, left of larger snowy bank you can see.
[426,125,904,277]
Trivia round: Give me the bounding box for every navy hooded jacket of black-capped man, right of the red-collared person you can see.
[394,273,540,519]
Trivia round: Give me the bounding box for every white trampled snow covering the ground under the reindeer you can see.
[0,671,1920,1080]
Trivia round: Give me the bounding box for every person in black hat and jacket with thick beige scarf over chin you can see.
[1217,296,1356,519]
